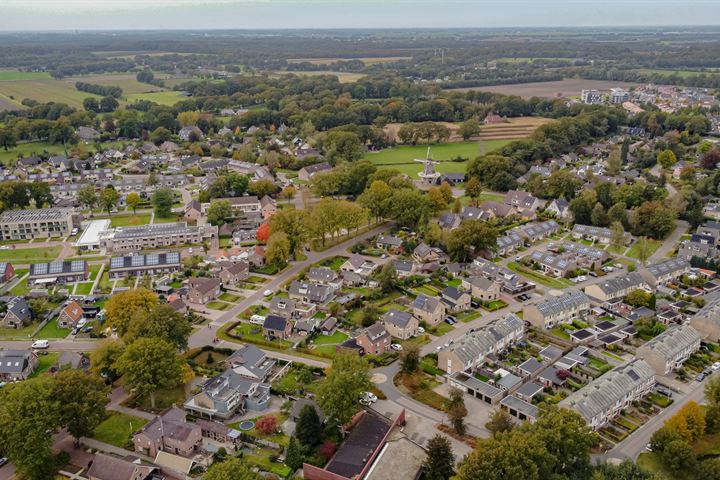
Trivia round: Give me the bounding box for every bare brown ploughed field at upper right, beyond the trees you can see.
[451,78,638,98]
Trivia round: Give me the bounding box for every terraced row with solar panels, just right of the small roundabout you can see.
[438,314,525,375]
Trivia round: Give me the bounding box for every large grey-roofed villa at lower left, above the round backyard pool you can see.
[184,368,270,420]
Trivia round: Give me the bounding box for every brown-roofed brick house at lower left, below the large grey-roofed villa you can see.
[133,407,202,458]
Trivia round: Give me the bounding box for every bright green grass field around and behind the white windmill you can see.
[365,140,510,176]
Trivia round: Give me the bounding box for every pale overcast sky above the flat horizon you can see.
[0,0,720,31]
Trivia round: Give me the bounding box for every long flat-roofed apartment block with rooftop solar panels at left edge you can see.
[0,208,73,240]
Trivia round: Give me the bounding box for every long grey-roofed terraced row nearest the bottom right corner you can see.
[559,358,655,430]
